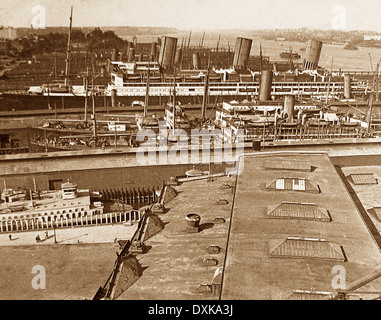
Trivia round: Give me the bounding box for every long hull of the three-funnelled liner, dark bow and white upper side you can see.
[0,82,366,111]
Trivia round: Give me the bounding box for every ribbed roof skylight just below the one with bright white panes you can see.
[267,202,331,222]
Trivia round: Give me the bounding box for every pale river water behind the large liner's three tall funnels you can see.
[124,31,381,71]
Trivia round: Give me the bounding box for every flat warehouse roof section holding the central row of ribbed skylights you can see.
[221,152,381,299]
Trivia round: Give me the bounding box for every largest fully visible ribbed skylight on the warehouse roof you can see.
[270,237,346,262]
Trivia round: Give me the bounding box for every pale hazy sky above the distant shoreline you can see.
[0,0,381,32]
